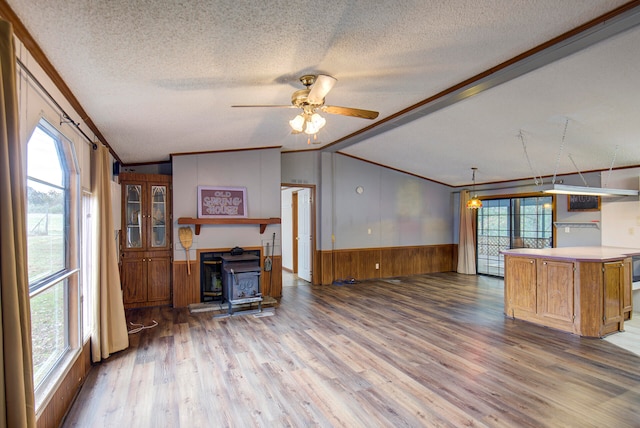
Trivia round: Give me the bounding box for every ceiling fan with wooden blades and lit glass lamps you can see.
[231,74,378,135]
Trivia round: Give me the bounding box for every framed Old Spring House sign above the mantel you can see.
[198,186,247,218]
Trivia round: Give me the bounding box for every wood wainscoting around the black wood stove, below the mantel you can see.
[173,247,282,308]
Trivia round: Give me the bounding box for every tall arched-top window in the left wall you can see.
[27,122,80,397]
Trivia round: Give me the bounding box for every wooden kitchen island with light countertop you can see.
[501,247,640,337]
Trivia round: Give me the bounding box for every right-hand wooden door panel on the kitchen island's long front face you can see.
[538,260,575,328]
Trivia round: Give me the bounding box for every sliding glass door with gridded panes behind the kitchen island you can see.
[476,196,553,276]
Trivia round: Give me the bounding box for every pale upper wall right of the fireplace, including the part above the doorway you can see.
[282,153,454,250]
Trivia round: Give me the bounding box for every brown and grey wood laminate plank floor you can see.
[63,273,640,428]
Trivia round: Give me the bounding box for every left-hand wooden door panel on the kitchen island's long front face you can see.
[504,257,536,318]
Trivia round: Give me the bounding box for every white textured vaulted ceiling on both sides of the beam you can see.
[7,0,640,186]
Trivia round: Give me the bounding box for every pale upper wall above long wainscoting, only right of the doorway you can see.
[332,155,453,249]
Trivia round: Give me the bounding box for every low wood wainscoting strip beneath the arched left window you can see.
[36,341,91,428]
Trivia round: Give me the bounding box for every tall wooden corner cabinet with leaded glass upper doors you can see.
[120,173,171,308]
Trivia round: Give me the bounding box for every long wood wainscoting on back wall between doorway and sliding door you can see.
[313,244,458,285]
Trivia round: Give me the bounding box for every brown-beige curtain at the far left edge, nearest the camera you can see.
[0,20,36,427]
